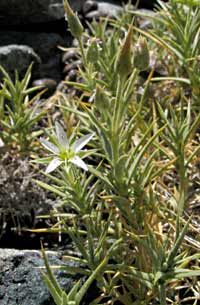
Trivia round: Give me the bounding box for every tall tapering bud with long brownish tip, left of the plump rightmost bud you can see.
[115,25,133,77]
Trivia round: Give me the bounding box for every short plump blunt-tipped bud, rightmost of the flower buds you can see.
[134,37,150,71]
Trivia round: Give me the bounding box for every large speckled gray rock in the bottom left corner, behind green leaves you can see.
[0,249,75,305]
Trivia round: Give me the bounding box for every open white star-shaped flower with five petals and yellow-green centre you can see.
[40,122,94,173]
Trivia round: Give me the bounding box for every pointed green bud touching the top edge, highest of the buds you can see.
[64,0,83,38]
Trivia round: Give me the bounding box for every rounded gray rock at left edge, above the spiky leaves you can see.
[0,45,41,77]
